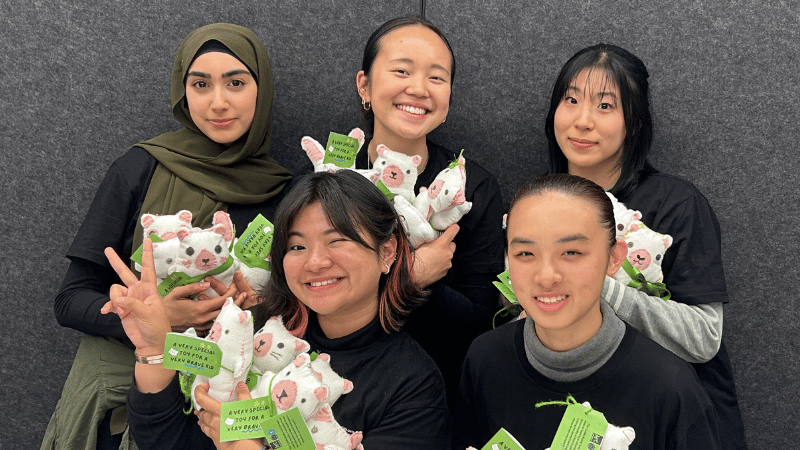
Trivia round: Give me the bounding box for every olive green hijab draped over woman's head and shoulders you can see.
[133,23,292,247]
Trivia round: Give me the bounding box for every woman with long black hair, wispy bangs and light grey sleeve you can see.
[545,44,746,449]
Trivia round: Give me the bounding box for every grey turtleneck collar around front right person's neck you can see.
[524,300,625,382]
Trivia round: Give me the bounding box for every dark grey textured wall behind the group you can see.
[0,0,800,449]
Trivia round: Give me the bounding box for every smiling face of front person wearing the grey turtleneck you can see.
[507,192,625,351]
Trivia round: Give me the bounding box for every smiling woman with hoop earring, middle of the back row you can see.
[356,17,503,404]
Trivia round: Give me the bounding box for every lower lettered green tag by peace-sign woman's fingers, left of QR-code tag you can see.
[219,396,277,442]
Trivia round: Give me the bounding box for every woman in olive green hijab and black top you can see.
[42,24,291,449]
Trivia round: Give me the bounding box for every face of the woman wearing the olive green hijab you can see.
[186,52,258,145]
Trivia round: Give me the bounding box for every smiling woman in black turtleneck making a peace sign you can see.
[104,171,450,450]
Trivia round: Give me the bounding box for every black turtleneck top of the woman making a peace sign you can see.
[128,316,450,450]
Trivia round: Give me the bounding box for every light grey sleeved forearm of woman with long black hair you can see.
[602,277,723,363]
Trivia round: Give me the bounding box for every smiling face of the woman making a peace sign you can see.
[283,202,397,338]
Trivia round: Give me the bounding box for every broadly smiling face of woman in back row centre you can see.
[356,25,452,149]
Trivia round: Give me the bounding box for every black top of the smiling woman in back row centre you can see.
[356,141,504,406]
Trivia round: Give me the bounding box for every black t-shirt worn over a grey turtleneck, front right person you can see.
[452,320,722,450]
